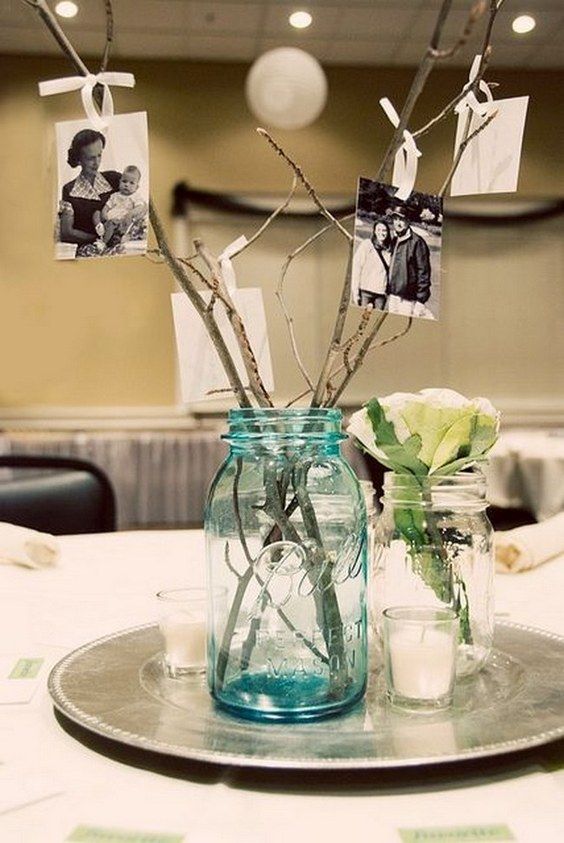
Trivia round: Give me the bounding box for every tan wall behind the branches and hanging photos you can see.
[0,57,564,418]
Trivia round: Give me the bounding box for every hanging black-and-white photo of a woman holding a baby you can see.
[55,112,149,260]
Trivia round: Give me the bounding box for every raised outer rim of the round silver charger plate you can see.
[47,621,564,770]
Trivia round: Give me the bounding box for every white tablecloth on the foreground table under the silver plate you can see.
[0,531,564,843]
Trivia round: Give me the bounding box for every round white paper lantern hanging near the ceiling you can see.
[245,47,327,129]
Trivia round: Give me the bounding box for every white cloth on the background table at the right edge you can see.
[485,430,564,521]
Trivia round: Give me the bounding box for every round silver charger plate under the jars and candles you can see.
[49,623,564,769]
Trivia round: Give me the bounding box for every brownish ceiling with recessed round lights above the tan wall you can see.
[0,0,564,68]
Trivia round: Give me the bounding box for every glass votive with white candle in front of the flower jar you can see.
[383,606,458,711]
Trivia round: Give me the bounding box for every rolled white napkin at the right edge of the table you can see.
[494,512,564,574]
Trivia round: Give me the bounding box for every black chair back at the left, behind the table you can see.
[0,454,116,535]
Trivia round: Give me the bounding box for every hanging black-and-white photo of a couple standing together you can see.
[351,178,443,319]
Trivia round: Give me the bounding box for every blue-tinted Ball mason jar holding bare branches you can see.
[205,408,367,720]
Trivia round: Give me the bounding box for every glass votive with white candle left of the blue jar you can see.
[157,588,207,679]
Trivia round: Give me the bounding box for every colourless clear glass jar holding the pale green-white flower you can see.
[371,471,494,677]
